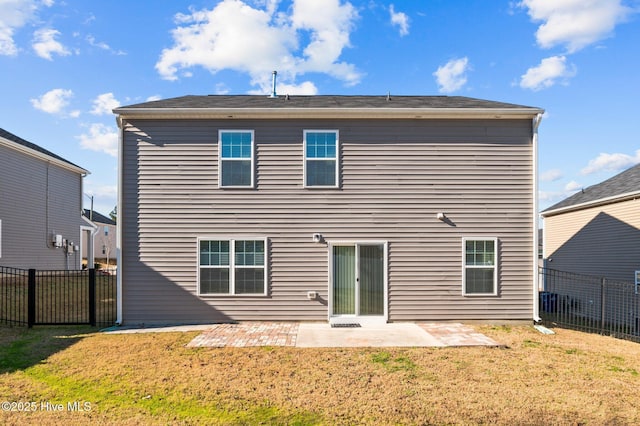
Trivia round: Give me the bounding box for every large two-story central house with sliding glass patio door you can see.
[114,95,543,324]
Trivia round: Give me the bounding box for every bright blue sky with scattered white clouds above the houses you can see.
[0,0,640,214]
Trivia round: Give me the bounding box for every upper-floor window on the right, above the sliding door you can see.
[304,130,339,188]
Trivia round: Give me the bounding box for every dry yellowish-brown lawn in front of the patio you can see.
[0,326,640,425]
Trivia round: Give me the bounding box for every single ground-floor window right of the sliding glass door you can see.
[462,238,498,295]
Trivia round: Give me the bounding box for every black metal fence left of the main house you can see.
[0,267,117,327]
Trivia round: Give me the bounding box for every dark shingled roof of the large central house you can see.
[114,95,537,110]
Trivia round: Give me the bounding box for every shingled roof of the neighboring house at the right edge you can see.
[542,164,640,215]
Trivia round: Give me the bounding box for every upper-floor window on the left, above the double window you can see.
[218,130,254,188]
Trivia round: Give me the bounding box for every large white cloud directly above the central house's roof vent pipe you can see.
[156,0,362,94]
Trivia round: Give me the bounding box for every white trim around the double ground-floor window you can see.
[196,235,269,297]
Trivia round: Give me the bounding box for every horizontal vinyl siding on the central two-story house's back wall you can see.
[120,120,534,323]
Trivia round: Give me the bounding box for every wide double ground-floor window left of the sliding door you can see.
[198,238,267,295]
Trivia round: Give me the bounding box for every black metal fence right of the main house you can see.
[540,268,640,342]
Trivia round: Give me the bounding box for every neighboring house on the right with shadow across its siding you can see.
[541,165,640,282]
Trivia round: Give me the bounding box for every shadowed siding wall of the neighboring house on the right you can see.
[544,199,640,282]
